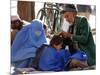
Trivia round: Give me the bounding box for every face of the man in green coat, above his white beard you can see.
[63,12,76,24]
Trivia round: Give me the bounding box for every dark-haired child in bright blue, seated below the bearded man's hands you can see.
[39,35,70,71]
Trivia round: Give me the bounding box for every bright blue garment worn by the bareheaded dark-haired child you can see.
[39,46,70,71]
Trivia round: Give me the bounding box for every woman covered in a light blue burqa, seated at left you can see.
[11,19,47,68]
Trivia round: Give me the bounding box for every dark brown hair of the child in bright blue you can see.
[50,35,63,46]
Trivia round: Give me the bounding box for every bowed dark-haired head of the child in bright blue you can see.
[50,35,63,50]
